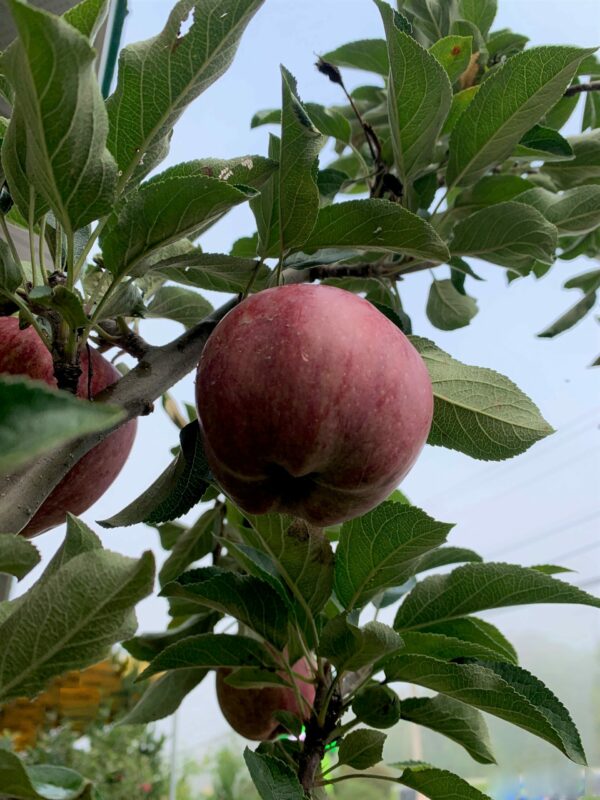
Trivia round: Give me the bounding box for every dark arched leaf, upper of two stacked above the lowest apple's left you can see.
[162,567,288,651]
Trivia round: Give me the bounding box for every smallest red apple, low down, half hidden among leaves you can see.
[217,658,315,742]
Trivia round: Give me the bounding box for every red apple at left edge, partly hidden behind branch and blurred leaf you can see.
[0,317,137,536]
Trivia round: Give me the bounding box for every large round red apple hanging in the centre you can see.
[196,284,433,526]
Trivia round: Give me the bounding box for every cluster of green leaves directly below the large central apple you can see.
[108,466,600,800]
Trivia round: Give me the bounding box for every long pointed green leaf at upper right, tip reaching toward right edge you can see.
[446,47,593,187]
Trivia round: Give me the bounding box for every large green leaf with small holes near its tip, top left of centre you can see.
[106,0,263,178]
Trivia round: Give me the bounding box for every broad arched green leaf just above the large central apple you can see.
[302,200,449,262]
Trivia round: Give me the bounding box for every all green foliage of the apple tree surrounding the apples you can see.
[0,0,600,800]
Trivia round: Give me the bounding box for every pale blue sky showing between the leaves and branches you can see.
[15,0,600,780]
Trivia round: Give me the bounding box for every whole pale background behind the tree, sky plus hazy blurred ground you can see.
[0,0,600,800]
